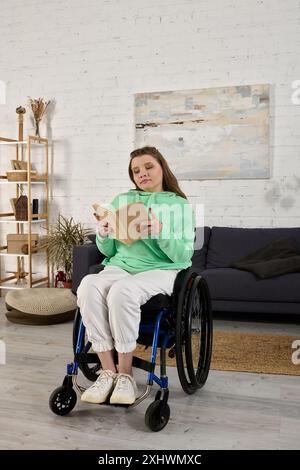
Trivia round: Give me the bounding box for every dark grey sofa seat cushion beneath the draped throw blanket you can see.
[201,268,300,302]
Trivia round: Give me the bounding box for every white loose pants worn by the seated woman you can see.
[77,266,180,353]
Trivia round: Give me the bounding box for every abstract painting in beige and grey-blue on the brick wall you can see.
[135,84,270,180]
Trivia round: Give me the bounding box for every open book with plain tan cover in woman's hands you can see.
[93,202,149,245]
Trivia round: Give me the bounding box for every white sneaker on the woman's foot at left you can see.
[81,370,117,403]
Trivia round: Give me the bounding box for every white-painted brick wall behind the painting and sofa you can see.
[0,0,300,227]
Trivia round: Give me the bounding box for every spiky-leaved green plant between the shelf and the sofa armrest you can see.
[38,214,93,287]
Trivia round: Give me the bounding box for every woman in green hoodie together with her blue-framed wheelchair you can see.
[50,146,212,431]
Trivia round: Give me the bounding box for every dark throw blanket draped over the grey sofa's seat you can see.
[230,238,300,279]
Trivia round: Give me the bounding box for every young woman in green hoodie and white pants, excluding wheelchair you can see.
[77,147,195,404]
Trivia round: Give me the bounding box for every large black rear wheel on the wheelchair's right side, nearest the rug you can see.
[175,273,212,394]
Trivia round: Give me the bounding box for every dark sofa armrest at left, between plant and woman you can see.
[72,243,105,294]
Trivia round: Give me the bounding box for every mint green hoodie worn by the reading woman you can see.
[96,189,195,273]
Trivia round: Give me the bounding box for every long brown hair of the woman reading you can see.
[128,146,187,199]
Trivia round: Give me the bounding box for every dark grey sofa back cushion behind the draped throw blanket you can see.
[206,227,300,268]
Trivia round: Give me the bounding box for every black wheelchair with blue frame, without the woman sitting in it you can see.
[49,268,213,432]
